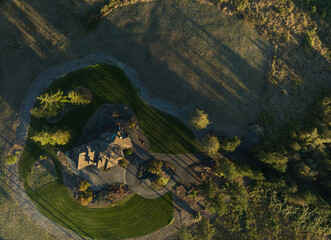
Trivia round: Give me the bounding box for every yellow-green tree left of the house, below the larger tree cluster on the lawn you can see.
[31,129,70,145]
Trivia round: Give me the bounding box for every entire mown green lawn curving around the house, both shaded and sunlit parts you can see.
[19,64,196,239]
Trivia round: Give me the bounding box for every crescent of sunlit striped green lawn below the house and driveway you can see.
[27,182,173,239]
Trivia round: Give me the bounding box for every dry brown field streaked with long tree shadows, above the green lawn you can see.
[0,0,273,135]
